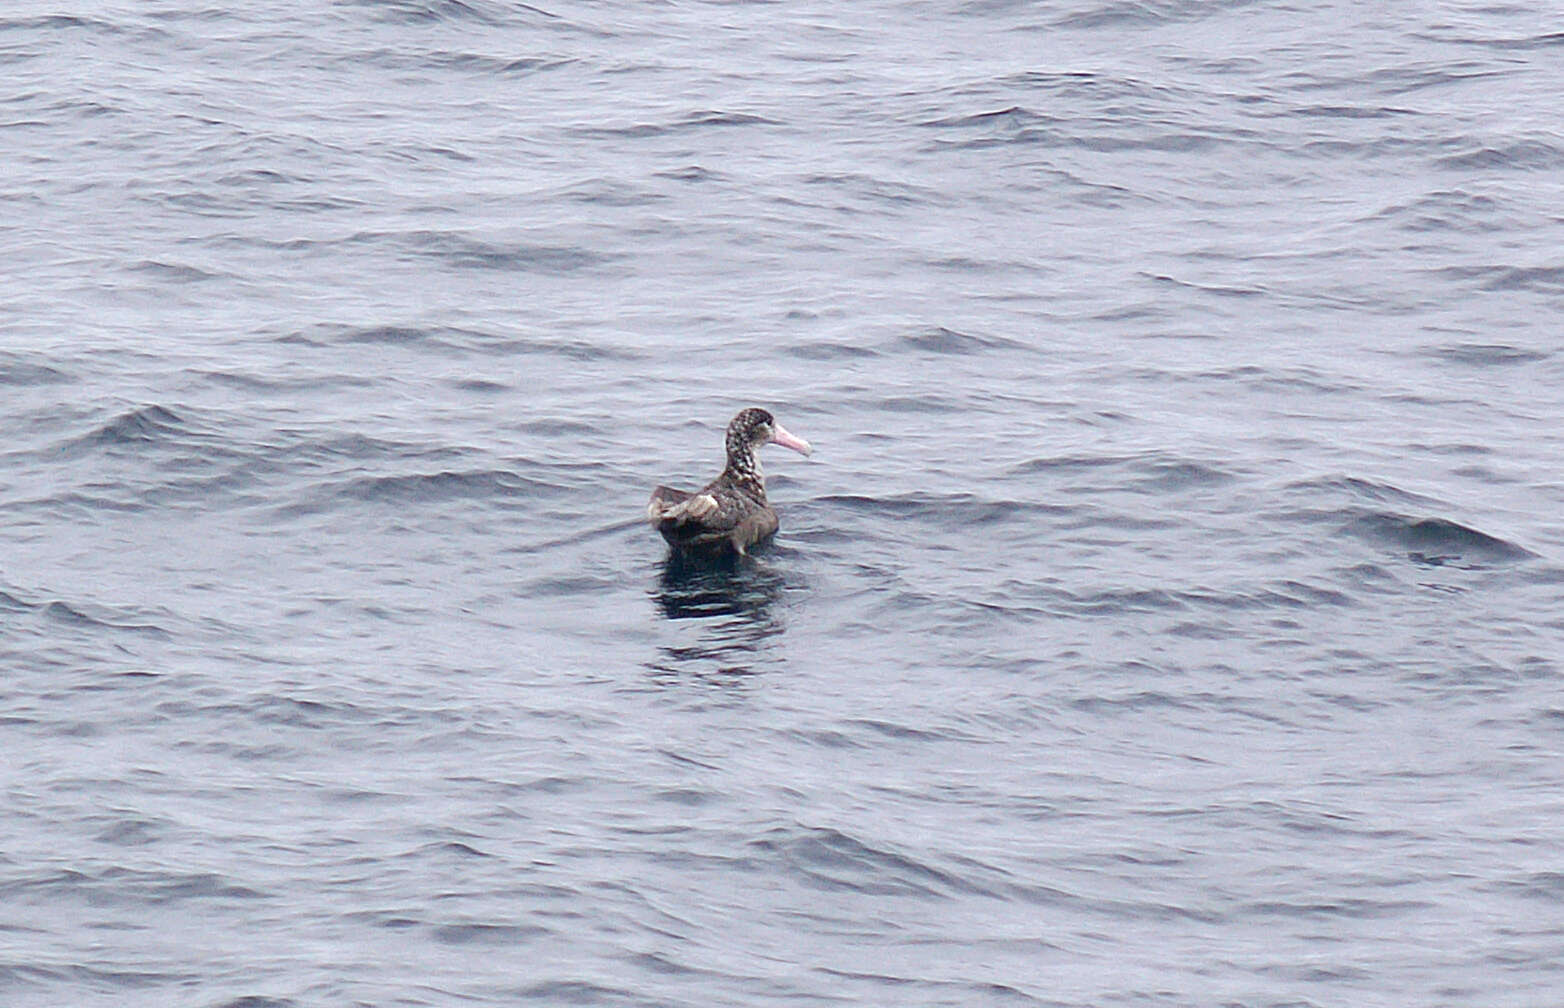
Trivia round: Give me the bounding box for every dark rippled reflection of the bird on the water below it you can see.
[647,553,788,678]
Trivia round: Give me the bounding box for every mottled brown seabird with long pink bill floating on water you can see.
[646,408,809,555]
